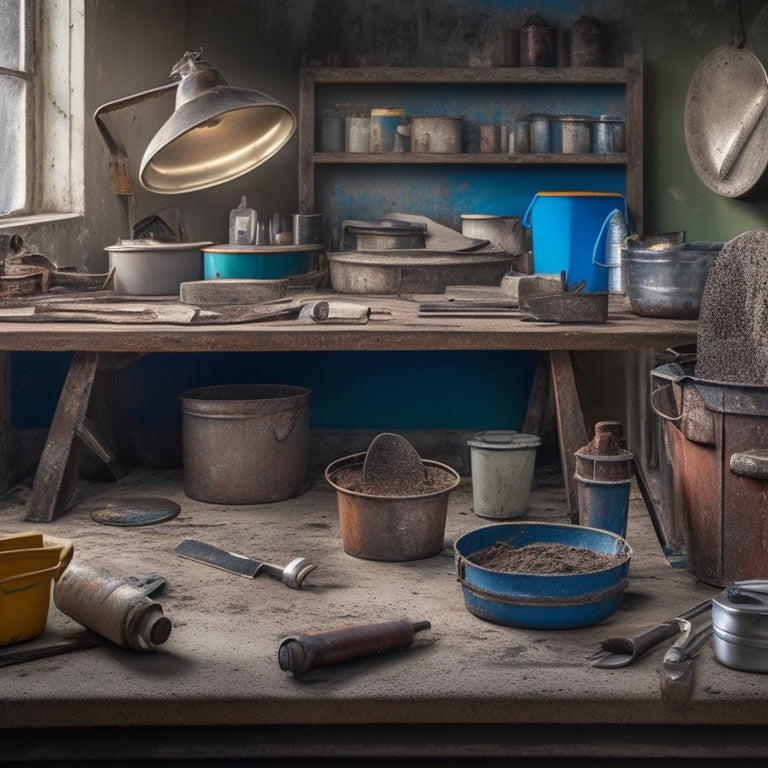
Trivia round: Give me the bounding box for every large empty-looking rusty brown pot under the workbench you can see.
[179,384,311,504]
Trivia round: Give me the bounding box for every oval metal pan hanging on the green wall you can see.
[685,45,768,197]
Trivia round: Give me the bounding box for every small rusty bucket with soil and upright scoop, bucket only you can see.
[325,453,461,562]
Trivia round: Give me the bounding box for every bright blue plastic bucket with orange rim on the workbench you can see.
[523,192,626,291]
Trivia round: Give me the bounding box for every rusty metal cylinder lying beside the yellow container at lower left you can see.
[53,562,172,651]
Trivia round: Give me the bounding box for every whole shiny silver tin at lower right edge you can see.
[712,580,768,672]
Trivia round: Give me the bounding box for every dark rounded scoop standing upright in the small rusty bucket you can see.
[363,432,427,495]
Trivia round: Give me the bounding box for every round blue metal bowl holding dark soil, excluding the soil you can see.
[454,522,632,629]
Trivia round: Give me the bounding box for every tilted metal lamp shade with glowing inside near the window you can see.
[140,85,296,194]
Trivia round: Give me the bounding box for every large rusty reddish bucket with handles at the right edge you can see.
[651,363,768,587]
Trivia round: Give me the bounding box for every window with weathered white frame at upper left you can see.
[0,0,84,225]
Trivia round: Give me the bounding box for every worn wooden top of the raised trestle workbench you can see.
[0,294,696,352]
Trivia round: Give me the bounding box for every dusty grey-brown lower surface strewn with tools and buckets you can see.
[0,470,768,757]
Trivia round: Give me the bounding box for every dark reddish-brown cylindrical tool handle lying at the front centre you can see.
[277,621,432,677]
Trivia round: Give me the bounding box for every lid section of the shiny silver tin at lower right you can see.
[712,580,768,651]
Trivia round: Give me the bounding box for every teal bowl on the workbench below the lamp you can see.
[203,245,322,280]
